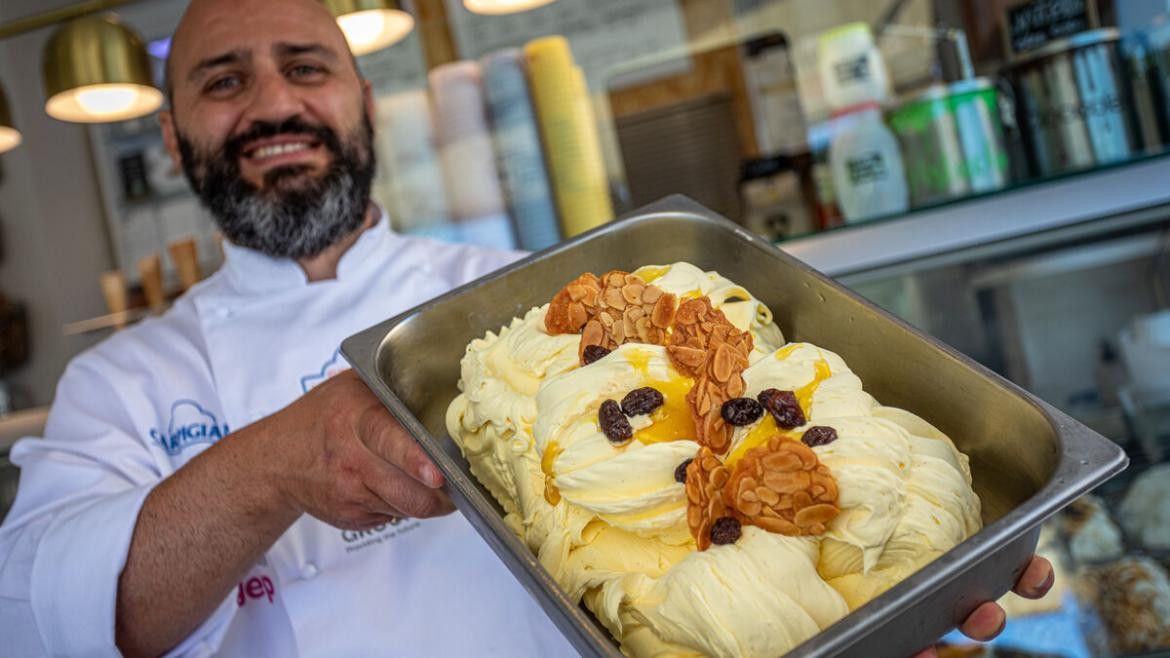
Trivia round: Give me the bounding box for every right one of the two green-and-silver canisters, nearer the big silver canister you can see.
[947,77,1009,193]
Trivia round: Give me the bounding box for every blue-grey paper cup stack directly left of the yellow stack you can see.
[481,48,560,252]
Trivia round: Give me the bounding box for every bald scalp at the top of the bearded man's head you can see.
[164,0,360,107]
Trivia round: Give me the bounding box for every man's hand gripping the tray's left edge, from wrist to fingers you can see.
[266,370,455,529]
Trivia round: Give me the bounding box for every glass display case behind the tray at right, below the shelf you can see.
[840,184,1170,657]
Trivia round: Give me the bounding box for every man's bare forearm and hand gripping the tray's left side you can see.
[115,371,454,656]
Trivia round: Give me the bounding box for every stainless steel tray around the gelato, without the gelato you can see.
[342,192,1128,657]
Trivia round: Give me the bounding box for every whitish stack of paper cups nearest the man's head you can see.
[377,89,459,241]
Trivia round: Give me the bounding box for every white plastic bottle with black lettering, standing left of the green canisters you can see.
[828,103,910,224]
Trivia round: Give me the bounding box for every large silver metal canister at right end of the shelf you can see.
[1006,28,1137,176]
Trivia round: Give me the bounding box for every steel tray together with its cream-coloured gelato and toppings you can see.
[342,197,1126,658]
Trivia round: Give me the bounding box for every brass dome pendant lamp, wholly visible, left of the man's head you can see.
[42,14,163,123]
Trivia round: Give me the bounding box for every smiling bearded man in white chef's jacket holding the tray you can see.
[0,0,1046,657]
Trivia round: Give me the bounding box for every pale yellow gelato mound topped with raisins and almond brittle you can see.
[447,262,982,657]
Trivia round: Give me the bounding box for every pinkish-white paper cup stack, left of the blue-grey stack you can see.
[428,61,516,248]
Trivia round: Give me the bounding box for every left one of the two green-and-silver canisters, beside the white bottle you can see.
[888,84,971,206]
